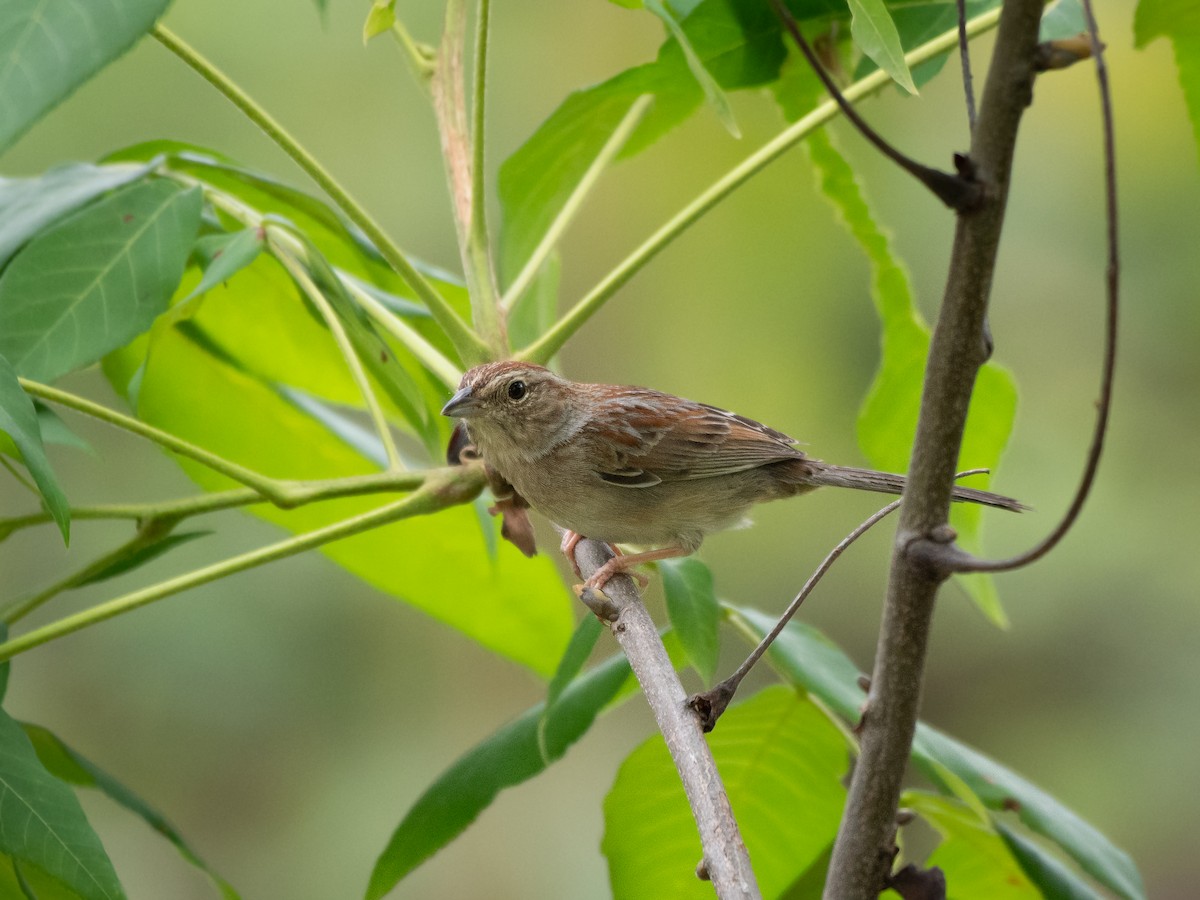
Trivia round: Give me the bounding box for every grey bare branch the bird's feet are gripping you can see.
[575,540,761,900]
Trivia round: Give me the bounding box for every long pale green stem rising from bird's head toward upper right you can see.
[516,8,1000,362]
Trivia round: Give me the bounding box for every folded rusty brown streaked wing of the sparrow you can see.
[587,389,804,487]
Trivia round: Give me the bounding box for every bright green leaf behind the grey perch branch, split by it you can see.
[601,686,847,900]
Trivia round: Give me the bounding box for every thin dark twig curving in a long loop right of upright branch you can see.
[913,0,1121,572]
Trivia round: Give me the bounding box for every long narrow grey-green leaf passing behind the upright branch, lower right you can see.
[731,607,1145,900]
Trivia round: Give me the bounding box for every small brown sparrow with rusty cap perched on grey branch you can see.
[442,361,1022,589]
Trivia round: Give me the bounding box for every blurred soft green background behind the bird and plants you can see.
[0,0,1200,900]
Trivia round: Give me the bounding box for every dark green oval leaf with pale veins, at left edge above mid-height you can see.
[0,180,200,382]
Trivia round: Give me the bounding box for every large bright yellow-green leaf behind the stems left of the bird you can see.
[106,257,571,676]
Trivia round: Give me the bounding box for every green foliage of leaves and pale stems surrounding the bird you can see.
[0,0,1166,898]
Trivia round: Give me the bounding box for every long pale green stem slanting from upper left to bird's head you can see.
[151,23,488,362]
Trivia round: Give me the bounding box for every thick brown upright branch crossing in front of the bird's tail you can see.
[824,0,1042,900]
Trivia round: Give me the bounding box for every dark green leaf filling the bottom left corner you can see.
[0,710,125,900]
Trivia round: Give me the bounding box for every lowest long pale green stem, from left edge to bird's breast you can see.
[0,467,484,661]
